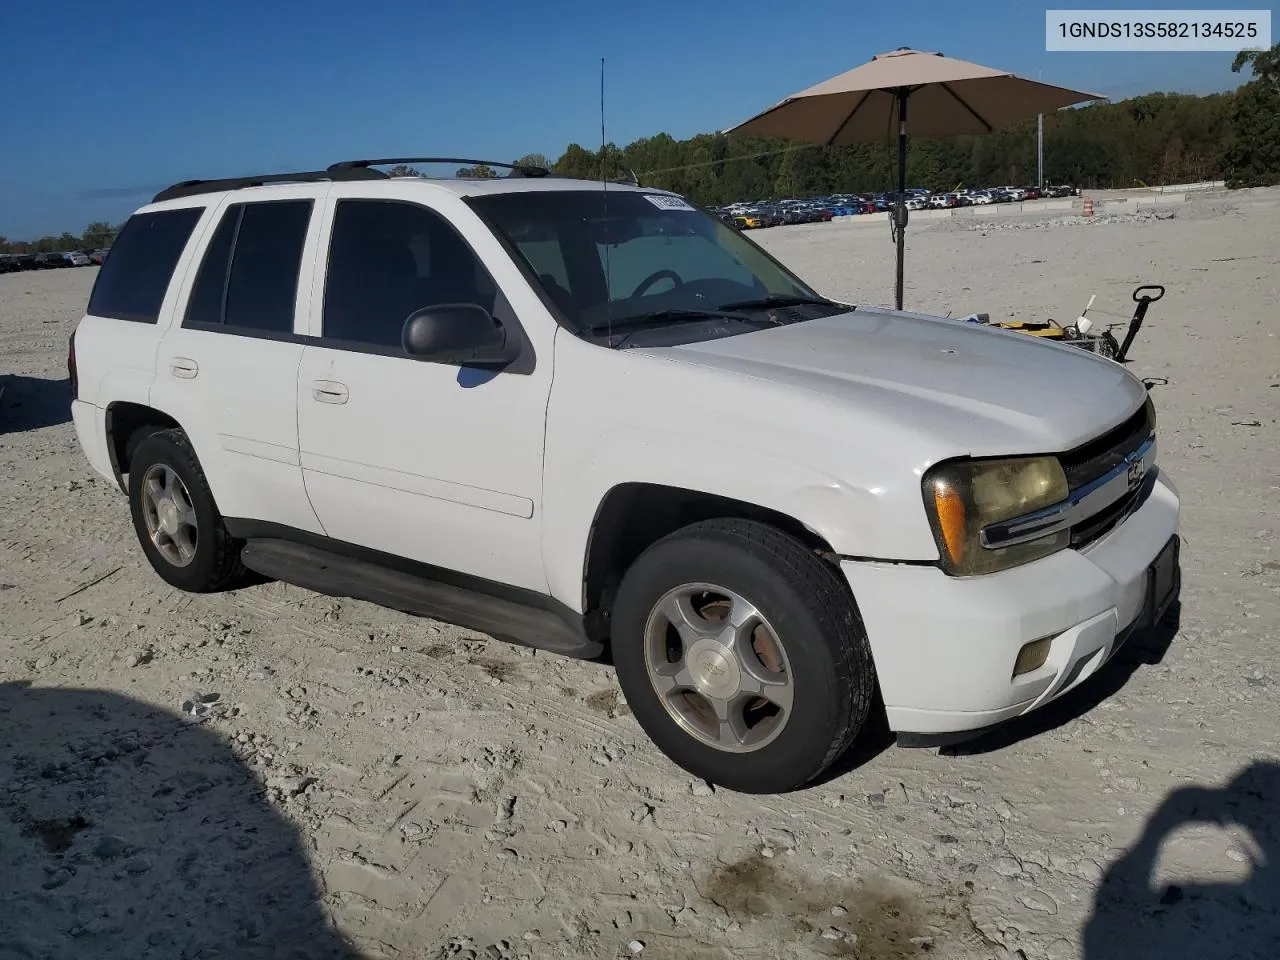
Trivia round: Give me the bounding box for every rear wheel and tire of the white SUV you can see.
[129,430,244,593]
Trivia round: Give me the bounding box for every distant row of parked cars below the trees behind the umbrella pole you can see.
[712,184,1079,230]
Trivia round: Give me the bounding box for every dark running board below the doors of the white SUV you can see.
[241,539,604,659]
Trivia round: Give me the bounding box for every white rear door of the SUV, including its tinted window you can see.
[152,188,323,532]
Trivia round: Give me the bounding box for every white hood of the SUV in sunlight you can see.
[643,307,1147,456]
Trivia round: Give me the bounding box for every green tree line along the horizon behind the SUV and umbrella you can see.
[0,44,1280,253]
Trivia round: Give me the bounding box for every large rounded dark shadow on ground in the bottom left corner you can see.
[0,682,358,960]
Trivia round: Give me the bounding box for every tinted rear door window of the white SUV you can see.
[184,200,312,333]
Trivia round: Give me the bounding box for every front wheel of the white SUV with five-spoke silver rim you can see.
[612,520,876,794]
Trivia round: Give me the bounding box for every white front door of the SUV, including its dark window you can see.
[298,192,552,593]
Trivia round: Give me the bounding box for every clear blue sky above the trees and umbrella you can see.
[0,0,1259,238]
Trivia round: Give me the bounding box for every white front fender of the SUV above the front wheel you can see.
[541,332,938,609]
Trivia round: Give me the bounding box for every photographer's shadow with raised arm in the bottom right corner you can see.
[1083,760,1280,960]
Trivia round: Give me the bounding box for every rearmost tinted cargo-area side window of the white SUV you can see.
[88,207,205,324]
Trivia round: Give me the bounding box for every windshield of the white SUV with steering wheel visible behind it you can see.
[468,189,827,343]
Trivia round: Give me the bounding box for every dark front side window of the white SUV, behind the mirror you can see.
[323,200,498,349]
